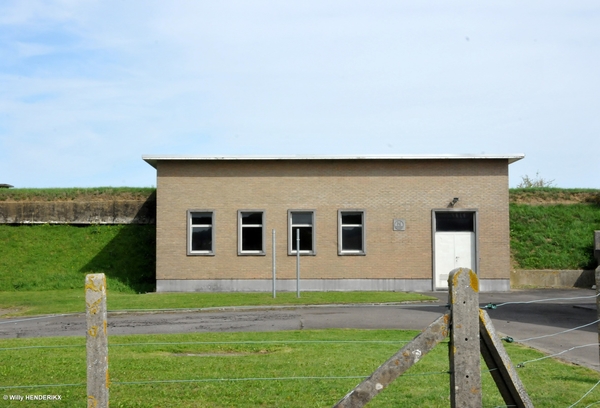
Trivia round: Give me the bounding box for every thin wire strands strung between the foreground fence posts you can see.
[0,295,600,408]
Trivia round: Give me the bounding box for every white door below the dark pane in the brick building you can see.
[434,231,476,289]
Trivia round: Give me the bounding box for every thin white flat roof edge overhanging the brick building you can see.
[142,153,525,168]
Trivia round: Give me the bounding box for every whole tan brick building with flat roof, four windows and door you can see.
[143,154,524,292]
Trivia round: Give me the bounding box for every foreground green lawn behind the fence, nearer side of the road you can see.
[0,329,600,408]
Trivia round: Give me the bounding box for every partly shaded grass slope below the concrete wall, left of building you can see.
[0,224,156,293]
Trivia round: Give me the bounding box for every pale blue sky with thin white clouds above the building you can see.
[0,0,600,188]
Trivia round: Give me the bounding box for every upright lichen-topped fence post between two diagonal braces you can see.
[448,268,482,408]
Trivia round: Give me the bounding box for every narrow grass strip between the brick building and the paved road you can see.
[0,287,437,317]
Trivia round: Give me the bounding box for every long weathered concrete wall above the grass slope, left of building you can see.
[0,199,156,224]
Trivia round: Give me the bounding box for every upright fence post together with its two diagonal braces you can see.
[334,268,532,408]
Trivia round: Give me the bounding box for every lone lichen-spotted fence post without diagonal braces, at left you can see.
[85,273,109,408]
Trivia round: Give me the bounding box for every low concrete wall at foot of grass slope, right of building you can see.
[510,269,596,289]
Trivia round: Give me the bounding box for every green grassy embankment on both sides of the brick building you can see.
[0,187,600,293]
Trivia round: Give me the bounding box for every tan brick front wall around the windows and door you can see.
[157,159,510,279]
